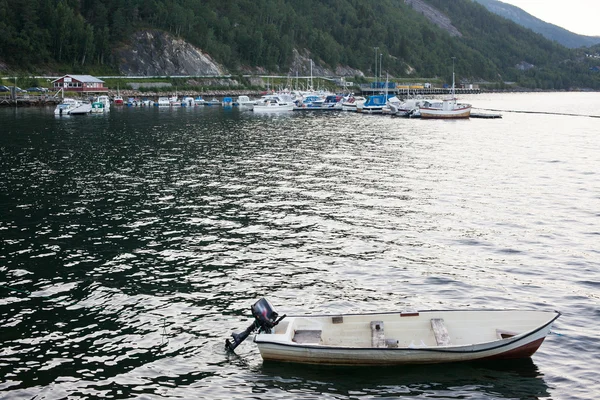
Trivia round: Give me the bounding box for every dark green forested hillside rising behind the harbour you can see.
[0,0,600,89]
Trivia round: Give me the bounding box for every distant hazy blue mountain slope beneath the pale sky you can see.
[474,0,600,48]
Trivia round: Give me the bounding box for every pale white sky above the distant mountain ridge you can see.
[500,0,600,36]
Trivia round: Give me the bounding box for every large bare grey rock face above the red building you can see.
[115,30,228,76]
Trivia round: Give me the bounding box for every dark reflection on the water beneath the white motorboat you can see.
[255,359,550,399]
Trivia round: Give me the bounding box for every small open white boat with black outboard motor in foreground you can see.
[226,298,560,365]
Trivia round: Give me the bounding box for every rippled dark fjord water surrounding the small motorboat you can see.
[0,93,600,399]
